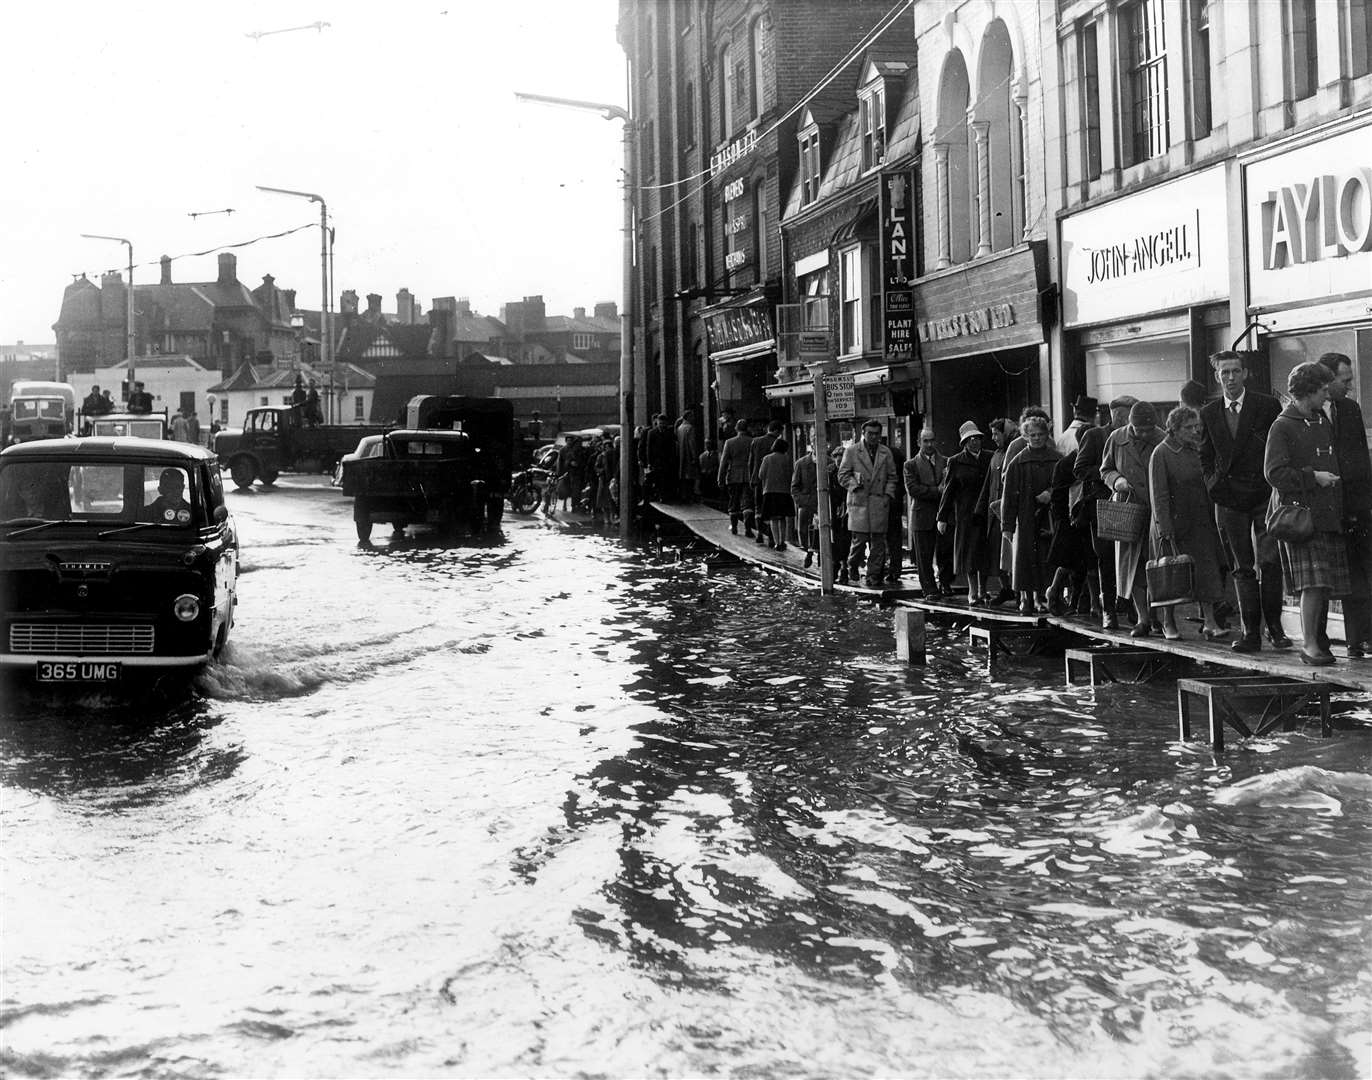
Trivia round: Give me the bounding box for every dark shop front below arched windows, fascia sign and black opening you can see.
[915,240,1047,450]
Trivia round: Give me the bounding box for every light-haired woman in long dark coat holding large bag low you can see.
[1148,405,1229,641]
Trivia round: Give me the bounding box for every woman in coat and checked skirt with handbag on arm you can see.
[1262,362,1351,667]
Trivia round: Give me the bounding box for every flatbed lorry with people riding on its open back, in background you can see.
[214,405,387,487]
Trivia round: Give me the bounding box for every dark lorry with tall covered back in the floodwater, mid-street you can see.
[342,394,515,541]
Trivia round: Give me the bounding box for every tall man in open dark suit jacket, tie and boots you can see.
[1201,351,1291,653]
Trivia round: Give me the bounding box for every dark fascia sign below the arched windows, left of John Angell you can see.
[915,240,1047,360]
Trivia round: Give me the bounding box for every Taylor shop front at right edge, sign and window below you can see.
[1242,115,1372,425]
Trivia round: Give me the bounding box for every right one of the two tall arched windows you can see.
[973,19,1024,251]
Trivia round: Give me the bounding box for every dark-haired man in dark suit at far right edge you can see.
[1320,353,1372,660]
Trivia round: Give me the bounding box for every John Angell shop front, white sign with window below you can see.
[1055,165,1232,419]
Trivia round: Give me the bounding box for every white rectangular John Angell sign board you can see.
[1062,165,1229,327]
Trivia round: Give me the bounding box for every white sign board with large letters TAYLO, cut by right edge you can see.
[1243,121,1372,309]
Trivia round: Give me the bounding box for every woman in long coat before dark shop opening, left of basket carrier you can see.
[1000,416,1062,615]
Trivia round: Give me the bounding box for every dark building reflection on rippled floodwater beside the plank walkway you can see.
[537,567,1372,1073]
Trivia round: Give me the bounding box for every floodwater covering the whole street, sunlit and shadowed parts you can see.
[0,480,1372,1077]
